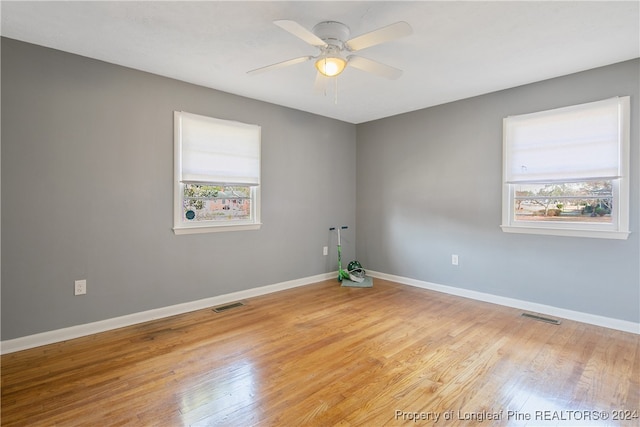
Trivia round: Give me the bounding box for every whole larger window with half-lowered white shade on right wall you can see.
[502,96,630,239]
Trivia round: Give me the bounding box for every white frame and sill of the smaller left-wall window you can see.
[173,111,262,235]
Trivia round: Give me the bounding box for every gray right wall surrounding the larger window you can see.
[356,60,640,322]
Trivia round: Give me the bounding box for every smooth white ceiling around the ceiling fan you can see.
[1,0,640,123]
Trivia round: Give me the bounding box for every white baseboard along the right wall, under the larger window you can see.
[367,270,640,334]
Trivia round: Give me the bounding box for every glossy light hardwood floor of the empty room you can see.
[1,279,640,426]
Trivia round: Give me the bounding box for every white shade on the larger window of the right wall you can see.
[504,96,629,183]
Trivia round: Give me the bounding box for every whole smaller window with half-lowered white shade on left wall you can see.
[173,111,260,234]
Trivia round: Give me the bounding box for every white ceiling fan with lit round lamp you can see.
[248,19,413,79]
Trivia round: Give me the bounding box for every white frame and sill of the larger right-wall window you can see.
[500,96,630,240]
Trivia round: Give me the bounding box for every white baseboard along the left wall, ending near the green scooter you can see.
[0,272,338,354]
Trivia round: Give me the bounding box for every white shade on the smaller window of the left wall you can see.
[175,111,261,185]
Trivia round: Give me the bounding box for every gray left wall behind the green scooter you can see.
[2,39,356,340]
